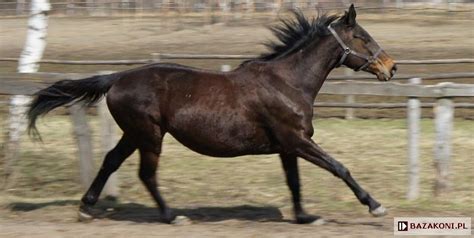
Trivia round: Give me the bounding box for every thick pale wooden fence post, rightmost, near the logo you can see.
[434,94,454,196]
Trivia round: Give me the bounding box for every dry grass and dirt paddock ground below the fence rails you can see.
[0,115,474,237]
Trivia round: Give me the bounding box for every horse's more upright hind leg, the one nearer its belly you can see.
[139,146,175,223]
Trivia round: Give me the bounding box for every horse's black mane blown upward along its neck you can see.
[249,10,339,61]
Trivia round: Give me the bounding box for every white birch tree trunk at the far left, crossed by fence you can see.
[5,0,51,188]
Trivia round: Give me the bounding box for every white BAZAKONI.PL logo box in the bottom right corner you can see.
[393,217,471,235]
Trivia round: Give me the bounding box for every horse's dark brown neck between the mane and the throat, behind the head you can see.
[281,39,341,103]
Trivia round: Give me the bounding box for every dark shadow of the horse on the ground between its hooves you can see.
[8,200,289,223]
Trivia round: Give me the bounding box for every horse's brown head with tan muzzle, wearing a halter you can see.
[329,5,397,81]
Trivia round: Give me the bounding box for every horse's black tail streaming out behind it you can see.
[27,74,118,137]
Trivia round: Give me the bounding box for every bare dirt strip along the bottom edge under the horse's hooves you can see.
[0,201,472,238]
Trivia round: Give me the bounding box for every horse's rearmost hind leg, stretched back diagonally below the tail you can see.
[79,135,136,219]
